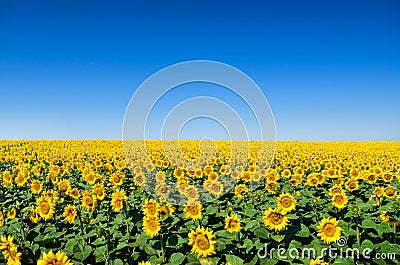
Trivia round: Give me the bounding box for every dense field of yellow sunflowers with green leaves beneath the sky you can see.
[0,141,400,265]
